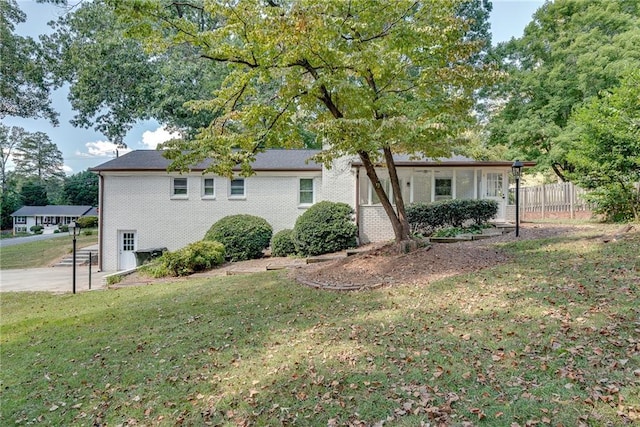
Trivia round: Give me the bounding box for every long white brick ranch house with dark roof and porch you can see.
[91,150,528,271]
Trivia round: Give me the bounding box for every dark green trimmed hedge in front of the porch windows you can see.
[407,199,498,236]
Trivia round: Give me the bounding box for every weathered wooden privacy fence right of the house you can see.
[520,182,591,220]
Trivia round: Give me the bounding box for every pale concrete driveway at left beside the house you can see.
[0,265,107,292]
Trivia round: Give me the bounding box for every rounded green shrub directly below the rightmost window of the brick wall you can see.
[293,201,358,255]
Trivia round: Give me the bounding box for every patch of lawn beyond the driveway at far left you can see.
[0,231,98,270]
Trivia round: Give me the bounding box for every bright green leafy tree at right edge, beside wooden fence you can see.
[569,70,640,222]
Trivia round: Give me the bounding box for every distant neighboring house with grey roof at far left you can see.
[11,205,97,234]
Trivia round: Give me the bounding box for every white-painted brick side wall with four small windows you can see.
[100,173,321,271]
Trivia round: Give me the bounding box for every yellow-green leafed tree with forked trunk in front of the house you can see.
[110,0,494,241]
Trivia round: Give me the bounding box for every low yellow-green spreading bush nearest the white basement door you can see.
[140,240,225,277]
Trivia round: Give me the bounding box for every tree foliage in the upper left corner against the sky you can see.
[0,0,58,125]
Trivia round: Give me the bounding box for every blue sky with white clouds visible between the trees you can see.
[2,0,544,175]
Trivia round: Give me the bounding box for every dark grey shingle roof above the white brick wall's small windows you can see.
[90,150,322,172]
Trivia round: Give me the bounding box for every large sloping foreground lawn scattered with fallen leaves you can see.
[0,226,640,426]
